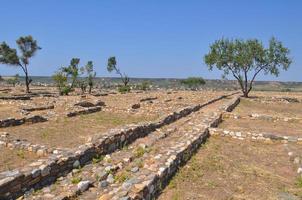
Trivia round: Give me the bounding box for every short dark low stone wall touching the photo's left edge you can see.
[0,115,47,128]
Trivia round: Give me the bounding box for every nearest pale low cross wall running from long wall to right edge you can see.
[210,128,302,144]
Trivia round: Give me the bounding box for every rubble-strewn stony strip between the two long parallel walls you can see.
[24,94,234,199]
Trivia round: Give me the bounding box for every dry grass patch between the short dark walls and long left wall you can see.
[1,112,154,148]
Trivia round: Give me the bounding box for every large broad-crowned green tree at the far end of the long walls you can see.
[204,38,292,97]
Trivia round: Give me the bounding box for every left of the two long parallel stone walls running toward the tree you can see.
[0,94,238,199]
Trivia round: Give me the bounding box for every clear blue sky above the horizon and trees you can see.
[0,0,302,81]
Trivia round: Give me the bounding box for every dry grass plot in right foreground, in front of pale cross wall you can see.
[159,137,302,200]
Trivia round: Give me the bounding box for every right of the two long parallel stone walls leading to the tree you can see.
[115,97,240,200]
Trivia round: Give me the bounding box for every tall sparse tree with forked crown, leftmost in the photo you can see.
[0,35,41,93]
